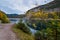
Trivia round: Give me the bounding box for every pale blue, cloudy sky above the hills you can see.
[0,0,53,14]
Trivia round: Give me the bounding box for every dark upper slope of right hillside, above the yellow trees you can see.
[27,0,60,12]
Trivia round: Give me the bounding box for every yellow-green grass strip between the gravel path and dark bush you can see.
[13,25,34,40]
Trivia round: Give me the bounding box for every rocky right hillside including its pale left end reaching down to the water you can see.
[26,1,60,20]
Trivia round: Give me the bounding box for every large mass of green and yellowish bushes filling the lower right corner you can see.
[35,20,60,40]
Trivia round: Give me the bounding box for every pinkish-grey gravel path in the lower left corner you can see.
[0,23,17,40]
